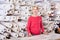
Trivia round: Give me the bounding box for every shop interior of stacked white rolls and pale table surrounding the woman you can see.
[0,0,60,40]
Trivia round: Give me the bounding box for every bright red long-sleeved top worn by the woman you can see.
[27,16,44,35]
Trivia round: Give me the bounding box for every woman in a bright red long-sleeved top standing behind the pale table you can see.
[27,6,44,36]
